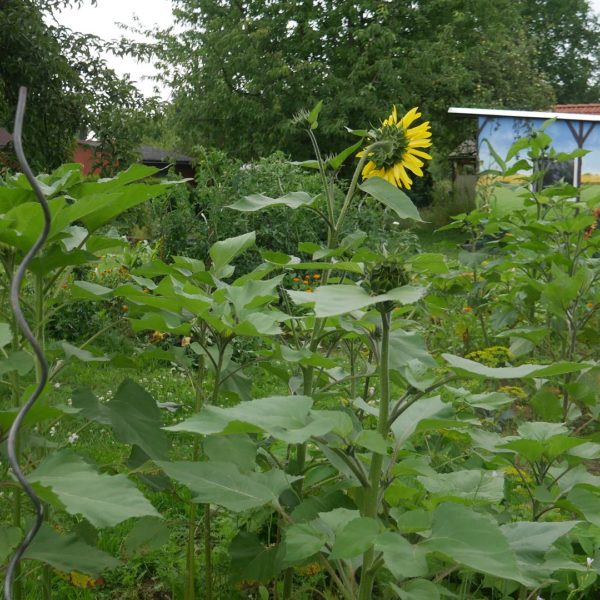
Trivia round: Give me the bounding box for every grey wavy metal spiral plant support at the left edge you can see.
[4,87,51,600]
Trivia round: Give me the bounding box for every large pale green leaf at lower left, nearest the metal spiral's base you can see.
[29,450,160,528]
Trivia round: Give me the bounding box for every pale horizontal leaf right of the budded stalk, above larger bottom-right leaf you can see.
[417,469,504,502]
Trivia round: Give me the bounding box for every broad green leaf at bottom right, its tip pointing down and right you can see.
[422,503,531,585]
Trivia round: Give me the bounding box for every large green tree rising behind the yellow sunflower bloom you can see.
[145,0,553,159]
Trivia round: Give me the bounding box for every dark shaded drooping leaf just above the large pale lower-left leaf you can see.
[73,379,169,459]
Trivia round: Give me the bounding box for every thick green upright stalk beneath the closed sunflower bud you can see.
[358,308,391,600]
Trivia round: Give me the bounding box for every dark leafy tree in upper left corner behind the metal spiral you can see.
[0,0,158,170]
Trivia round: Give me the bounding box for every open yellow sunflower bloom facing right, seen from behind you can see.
[357,106,431,190]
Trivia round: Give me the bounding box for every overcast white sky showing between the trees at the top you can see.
[58,0,600,97]
